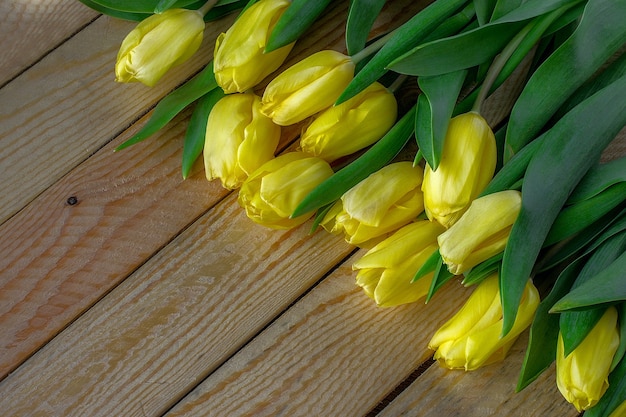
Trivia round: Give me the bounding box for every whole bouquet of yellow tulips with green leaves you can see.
[80,0,626,417]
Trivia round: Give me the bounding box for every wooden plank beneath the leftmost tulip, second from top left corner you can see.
[0,13,221,222]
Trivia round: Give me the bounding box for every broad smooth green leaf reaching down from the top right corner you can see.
[505,0,626,161]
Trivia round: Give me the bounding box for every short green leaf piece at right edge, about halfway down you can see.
[567,157,626,204]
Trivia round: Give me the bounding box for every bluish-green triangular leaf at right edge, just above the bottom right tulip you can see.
[551,245,626,312]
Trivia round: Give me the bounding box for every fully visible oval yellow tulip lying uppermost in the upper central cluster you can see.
[261,50,354,126]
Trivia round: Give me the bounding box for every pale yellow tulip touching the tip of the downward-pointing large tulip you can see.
[437,190,522,275]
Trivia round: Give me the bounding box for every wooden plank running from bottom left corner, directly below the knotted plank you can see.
[0,195,352,417]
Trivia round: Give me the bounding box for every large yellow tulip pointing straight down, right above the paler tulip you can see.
[422,112,497,228]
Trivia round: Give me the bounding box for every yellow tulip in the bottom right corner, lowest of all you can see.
[556,307,619,411]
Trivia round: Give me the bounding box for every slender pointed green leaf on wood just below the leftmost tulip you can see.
[115,63,217,151]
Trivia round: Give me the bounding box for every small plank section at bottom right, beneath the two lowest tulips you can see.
[379,333,579,417]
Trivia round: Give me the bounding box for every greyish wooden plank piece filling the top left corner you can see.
[0,0,98,85]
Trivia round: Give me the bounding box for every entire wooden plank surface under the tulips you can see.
[0,0,623,417]
